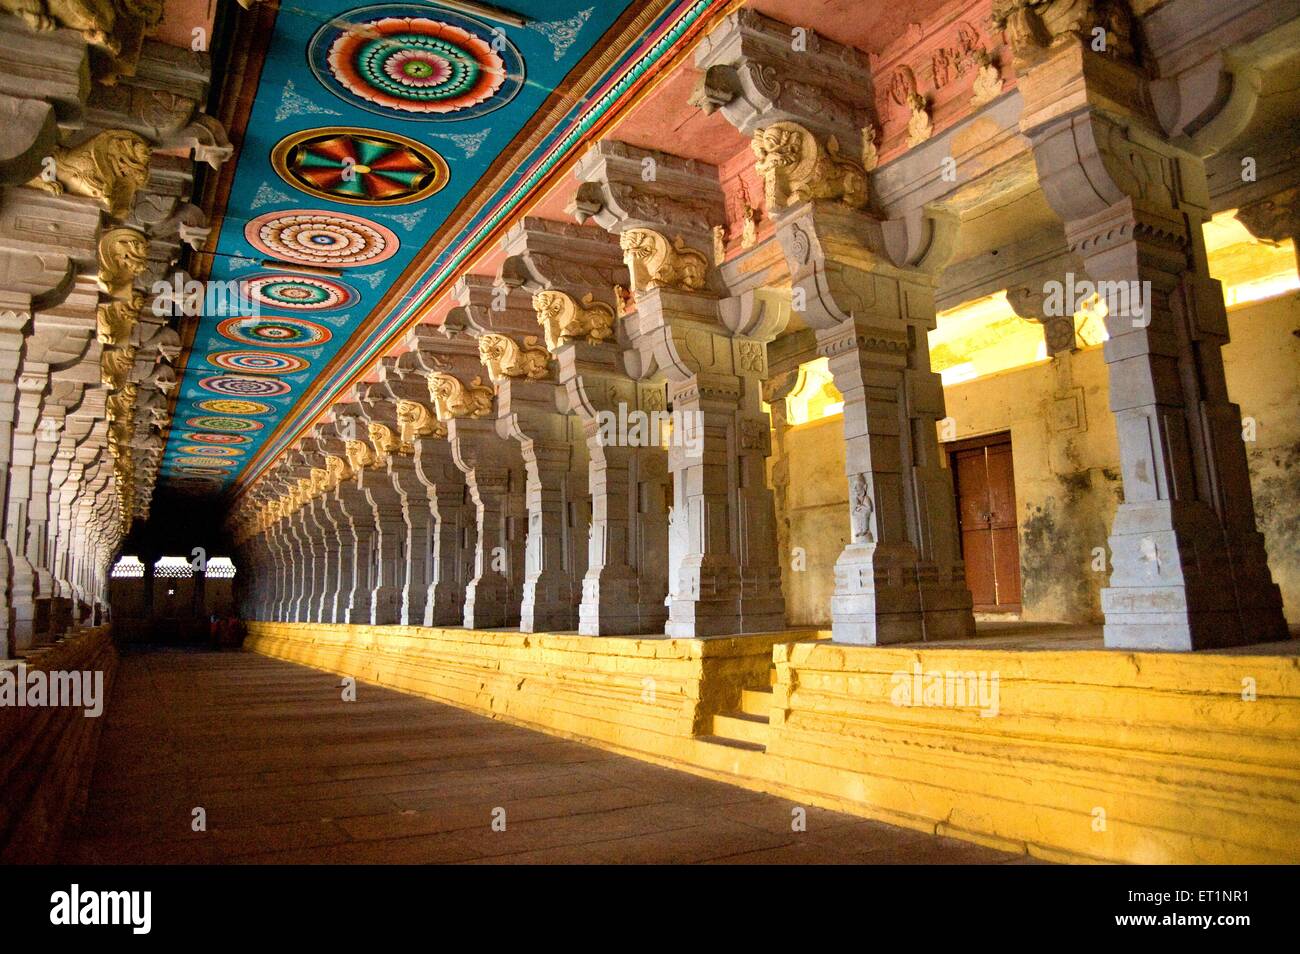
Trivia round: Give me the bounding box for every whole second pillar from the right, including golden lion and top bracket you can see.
[692,9,974,643]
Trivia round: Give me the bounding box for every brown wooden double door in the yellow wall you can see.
[949,434,1021,612]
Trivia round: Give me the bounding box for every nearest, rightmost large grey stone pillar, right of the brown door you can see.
[1009,11,1286,650]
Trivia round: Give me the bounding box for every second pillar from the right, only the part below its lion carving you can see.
[761,196,974,645]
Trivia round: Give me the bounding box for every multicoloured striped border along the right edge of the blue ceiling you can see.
[233,0,737,496]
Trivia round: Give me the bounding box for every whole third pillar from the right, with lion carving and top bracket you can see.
[572,140,789,636]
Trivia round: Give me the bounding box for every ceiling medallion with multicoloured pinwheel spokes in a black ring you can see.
[270,126,449,205]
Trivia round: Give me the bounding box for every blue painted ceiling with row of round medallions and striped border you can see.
[163,0,720,493]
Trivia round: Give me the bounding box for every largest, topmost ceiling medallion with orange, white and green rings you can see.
[308,4,524,122]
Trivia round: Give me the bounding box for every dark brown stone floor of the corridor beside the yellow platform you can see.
[62,651,1024,864]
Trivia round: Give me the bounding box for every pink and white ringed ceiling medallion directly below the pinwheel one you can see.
[244,209,400,268]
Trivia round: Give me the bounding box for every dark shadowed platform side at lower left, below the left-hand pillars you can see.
[0,626,117,864]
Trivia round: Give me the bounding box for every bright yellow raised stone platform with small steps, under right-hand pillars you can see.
[246,623,1300,863]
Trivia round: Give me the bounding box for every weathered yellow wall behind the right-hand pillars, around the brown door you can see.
[783,295,1300,626]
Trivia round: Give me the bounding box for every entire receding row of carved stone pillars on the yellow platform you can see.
[235,10,1284,650]
